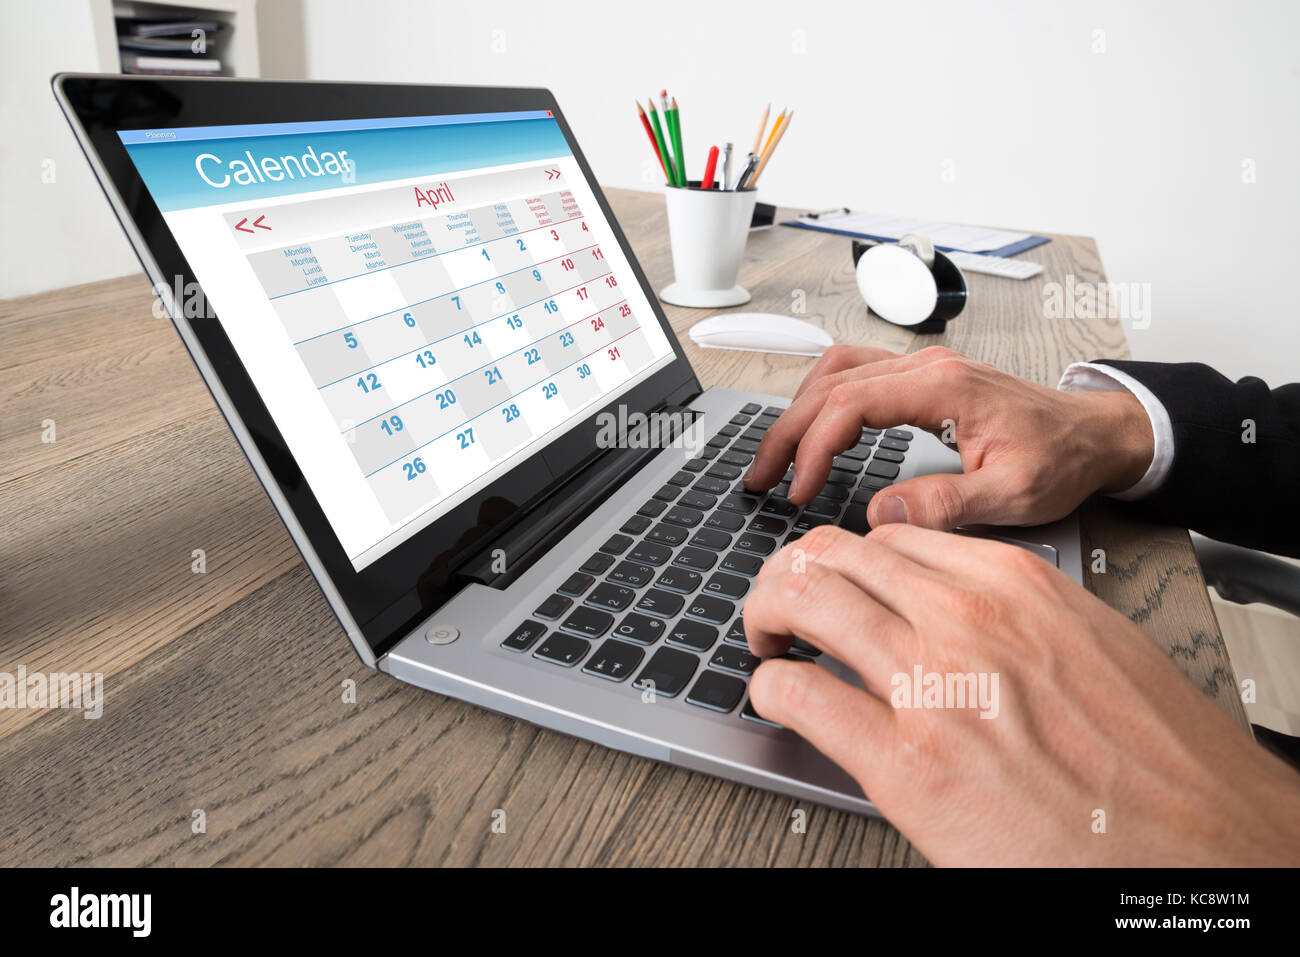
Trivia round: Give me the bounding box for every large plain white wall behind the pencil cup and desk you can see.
[303,0,1300,381]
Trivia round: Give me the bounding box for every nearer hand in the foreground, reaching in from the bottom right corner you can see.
[745,525,1300,866]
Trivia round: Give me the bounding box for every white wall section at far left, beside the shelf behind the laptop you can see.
[0,0,139,299]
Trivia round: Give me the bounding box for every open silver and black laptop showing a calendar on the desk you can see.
[53,74,1082,814]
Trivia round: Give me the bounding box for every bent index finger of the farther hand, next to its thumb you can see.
[785,361,959,503]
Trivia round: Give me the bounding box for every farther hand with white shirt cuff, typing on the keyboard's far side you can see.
[745,346,1154,528]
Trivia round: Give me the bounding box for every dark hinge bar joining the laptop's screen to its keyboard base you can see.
[455,404,701,588]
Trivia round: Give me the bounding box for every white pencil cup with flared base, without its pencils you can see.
[659,186,758,309]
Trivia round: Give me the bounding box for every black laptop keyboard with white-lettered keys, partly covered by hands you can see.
[502,403,913,727]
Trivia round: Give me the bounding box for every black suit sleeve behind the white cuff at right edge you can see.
[1099,359,1300,557]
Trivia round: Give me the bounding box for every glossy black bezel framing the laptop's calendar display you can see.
[53,74,699,657]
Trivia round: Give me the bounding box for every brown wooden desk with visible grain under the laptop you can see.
[0,191,1245,865]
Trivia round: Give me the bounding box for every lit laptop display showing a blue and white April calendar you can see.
[118,111,673,570]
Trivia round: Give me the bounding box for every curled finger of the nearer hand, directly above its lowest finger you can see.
[744,566,907,694]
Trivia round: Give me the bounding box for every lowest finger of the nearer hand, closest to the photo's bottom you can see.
[749,659,894,796]
